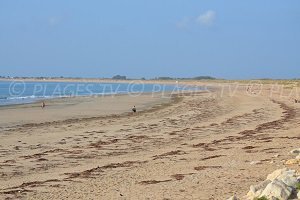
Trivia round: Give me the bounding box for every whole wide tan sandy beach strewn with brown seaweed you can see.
[0,82,300,200]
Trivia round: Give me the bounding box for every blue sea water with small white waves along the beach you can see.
[0,81,199,106]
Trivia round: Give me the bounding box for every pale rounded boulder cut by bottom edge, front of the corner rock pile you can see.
[260,179,292,200]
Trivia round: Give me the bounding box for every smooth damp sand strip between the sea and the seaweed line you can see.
[0,92,180,128]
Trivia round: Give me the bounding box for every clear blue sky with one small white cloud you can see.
[0,0,300,79]
